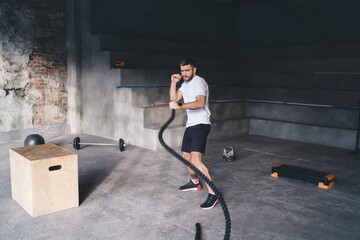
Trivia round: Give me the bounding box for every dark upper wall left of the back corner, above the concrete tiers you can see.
[92,0,236,46]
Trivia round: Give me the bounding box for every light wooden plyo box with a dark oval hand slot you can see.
[10,144,79,217]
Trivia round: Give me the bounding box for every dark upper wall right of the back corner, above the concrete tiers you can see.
[236,0,360,48]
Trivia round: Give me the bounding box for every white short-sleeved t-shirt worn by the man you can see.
[179,76,211,127]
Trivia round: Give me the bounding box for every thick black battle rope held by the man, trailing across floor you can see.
[158,109,231,240]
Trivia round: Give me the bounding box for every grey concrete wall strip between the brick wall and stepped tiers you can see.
[68,1,121,139]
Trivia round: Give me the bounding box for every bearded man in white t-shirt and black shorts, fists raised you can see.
[169,59,219,209]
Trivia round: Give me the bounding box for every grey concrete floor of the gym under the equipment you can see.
[0,135,360,240]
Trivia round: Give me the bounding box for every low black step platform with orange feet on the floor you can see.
[271,164,335,188]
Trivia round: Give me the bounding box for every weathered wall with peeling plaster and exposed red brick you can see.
[0,0,68,132]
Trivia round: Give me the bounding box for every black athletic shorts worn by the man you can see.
[181,124,211,154]
